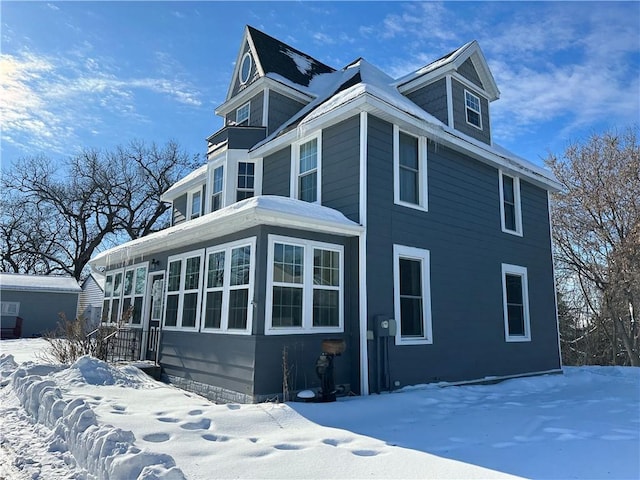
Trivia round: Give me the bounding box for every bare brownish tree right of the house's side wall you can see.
[547,127,640,366]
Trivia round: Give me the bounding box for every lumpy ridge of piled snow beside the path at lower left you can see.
[9,355,185,480]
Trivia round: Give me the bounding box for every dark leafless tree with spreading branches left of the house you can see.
[0,142,197,279]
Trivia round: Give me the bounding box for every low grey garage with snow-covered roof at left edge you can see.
[0,273,81,337]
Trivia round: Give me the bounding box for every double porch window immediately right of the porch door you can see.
[164,250,204,330]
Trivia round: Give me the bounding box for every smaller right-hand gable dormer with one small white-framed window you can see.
[395,40,500,145]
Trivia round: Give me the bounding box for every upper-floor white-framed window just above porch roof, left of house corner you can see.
[291,134,321,203]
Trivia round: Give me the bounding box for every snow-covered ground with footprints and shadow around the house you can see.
[0,340,640,480]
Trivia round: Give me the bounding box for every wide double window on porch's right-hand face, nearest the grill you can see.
[266,235,344,335]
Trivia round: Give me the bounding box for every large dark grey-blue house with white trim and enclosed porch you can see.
[91,26,561,402]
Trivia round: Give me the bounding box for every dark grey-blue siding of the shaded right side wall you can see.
[367,117,559,389]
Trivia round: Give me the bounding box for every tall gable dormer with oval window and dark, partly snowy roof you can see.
[216,25,334,134]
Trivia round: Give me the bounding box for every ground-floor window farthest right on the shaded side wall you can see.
[502,263,531,342]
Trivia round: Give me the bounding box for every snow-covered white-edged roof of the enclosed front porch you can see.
[89,195,363,267]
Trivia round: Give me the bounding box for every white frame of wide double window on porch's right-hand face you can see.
[264,235,344,335]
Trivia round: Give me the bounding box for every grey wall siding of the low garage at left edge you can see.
[0,289,79,337]
